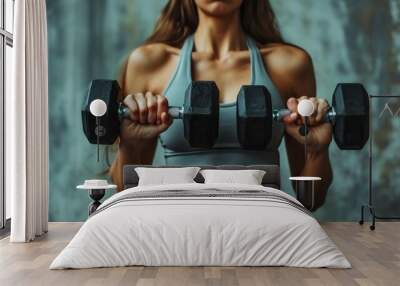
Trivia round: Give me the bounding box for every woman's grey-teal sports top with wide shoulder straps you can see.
[156,35,284,165]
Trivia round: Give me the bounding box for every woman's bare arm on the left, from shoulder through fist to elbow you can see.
[110,46,168,191]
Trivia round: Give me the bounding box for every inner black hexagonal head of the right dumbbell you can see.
[236,85,273,150]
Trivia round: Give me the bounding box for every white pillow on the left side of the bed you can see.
[135,167,200,186]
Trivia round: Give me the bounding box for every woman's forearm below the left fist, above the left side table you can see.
[110,138,157,192]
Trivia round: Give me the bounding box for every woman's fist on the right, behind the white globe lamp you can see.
[283,96,332,151]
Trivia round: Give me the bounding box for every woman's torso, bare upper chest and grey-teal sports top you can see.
[142,37,283,165]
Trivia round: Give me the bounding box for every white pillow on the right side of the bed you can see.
[200,169,265,185]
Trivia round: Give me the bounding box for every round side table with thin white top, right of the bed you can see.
[289,176,322,211]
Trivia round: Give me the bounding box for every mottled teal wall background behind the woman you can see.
[47,0,400,221]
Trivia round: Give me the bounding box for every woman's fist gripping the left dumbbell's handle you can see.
[120,92,172,144]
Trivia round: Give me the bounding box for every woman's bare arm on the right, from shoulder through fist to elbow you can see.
[261,45,332,208]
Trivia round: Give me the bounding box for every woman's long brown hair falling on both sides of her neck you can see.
[144,0,283,47]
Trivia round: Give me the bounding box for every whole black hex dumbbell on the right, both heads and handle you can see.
[237,83,369,150]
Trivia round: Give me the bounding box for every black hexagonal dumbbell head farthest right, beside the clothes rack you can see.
[332,83,369,150]
